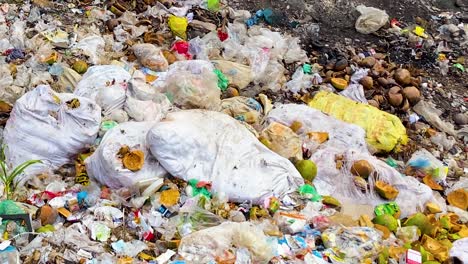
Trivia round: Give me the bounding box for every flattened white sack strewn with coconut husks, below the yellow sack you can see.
[265,104,435,217]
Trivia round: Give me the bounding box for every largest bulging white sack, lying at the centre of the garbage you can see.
[148,110,304,204]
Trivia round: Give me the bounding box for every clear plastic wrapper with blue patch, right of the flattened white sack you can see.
[407,149,448,182]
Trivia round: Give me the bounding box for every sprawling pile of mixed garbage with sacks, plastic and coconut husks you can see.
[0,0,468,264]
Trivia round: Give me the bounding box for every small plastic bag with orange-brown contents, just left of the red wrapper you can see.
[132,43,169,71]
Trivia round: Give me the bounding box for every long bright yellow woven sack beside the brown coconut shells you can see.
[309,91,408,151]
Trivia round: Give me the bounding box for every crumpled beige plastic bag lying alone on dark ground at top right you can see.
[355,5,388,34]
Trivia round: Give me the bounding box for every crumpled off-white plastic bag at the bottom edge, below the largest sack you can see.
[178,222,275,263]
